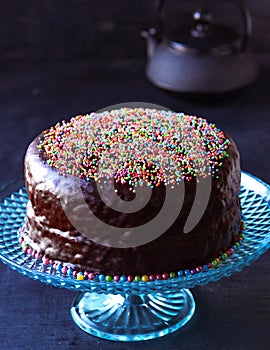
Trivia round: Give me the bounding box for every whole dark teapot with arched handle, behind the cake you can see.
[141,0,258,94]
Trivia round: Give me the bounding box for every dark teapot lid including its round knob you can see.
[165,9,241,53]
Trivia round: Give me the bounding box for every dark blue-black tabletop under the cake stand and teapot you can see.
[0,1,270,350]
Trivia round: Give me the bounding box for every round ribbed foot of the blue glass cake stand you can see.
[70,289,195,341]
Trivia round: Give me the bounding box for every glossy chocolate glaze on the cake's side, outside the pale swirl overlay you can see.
[23,133,241,275]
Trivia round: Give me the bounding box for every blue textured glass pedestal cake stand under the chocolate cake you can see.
[0,172,270,341]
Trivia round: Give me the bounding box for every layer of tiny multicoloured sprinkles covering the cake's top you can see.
[38,108,230,190]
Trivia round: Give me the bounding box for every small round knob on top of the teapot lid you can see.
[191,8,212,38]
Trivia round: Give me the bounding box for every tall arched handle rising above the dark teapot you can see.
[155,0,252,52]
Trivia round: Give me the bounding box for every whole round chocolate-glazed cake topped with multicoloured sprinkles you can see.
[21,108,241,276]
